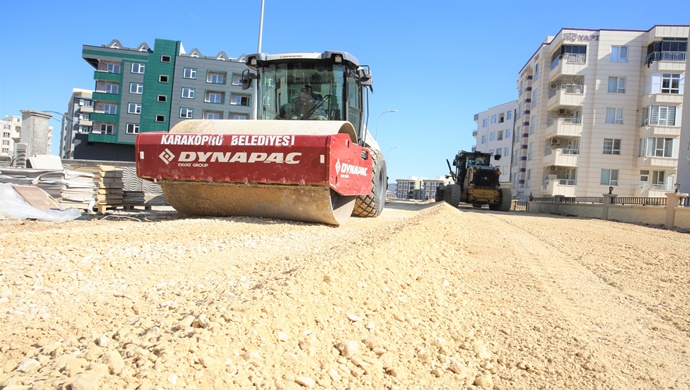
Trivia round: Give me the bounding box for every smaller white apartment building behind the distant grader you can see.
[472,100,517,184]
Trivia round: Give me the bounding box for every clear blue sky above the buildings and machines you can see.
[0,0,690,179]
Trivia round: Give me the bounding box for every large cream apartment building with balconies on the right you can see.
[511,25,689,199]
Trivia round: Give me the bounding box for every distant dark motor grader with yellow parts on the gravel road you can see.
[434,151,512,211]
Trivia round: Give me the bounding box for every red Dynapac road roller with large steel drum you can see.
[135,51,387,226]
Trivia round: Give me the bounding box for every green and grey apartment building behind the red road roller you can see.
[73,39,253,161]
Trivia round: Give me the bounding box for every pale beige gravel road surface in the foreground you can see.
[0,202,690,389]
